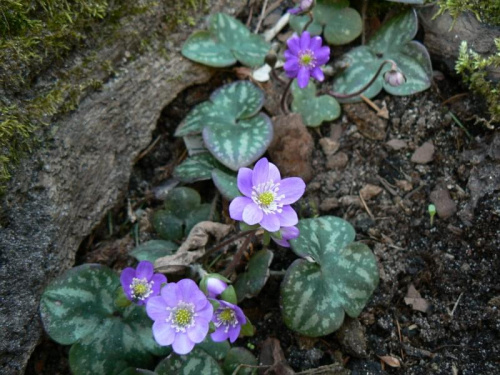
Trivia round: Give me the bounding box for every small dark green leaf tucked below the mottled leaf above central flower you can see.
[174,152,222,183]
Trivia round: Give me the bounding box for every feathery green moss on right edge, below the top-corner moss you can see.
[455,38,500,129]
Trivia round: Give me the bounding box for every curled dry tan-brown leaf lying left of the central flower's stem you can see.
[155,221,231,274]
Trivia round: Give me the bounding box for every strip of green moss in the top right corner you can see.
[436,0,500,25]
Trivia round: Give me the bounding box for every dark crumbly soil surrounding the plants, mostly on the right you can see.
[26,10,500,375]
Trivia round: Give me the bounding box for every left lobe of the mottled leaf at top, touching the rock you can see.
[181,31,236,68]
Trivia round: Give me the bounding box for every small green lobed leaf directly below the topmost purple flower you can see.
[292,81,340,127]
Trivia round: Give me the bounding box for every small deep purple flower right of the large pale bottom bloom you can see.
[210,301,247,342]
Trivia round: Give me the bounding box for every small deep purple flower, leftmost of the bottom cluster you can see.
[120,260,167,305]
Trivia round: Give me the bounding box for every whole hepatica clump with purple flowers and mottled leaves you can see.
[40,0,442,375]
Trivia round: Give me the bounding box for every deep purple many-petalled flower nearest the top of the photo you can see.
[284,31,330,89]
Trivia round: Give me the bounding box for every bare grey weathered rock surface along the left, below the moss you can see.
[0,0,245,375]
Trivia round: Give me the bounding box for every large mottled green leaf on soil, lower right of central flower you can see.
[281,216,379,337]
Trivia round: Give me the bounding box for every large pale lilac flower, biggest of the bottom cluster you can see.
[146,279,213,355]
